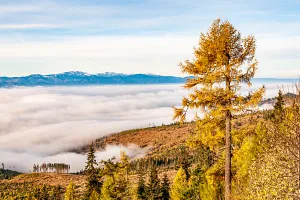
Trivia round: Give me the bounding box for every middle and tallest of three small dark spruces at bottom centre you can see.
[147,165,162,200]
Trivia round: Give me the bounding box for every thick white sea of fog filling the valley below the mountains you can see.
[0,80,292,172]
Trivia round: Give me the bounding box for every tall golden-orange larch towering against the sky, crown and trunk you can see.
[174,19,264,200]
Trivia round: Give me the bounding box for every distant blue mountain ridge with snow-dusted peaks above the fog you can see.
[0,71,297,88]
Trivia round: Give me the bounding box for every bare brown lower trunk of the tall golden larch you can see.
[225,111,231,200]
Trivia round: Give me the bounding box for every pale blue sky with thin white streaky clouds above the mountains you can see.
[0,0,300,78]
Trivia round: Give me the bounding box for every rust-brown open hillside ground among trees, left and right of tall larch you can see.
[0,114,263,197]
